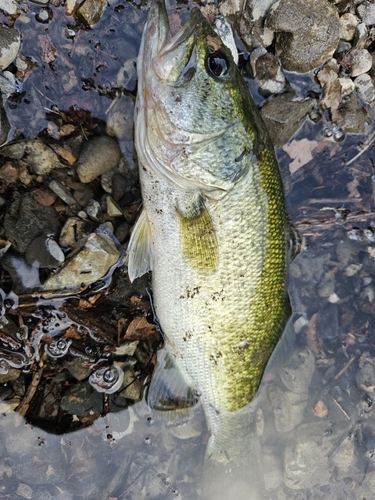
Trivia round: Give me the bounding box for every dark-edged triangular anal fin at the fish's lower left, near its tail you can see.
[147,348,198,412]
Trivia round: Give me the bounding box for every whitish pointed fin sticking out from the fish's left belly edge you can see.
[127,209,153,281]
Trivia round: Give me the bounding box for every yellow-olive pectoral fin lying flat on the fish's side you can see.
[177,195,219,273]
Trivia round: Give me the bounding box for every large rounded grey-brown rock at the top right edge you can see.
[265,0,339,73]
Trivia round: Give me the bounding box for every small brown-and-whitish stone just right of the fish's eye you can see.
[250,47,285,96]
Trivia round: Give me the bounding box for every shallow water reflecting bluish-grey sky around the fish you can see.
[0,1,375,500]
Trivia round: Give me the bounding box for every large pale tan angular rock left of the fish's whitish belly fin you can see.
[43,233,120,290]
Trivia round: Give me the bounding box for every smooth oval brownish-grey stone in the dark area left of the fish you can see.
[77,136,121,184]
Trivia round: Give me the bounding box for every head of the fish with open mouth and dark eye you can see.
[135,0,262,192]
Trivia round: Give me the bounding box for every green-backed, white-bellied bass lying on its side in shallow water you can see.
[128,0,290,476]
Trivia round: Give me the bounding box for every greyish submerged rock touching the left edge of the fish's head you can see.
[106,95,134,141]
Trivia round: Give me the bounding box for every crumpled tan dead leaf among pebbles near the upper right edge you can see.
[316,61,342,122]
